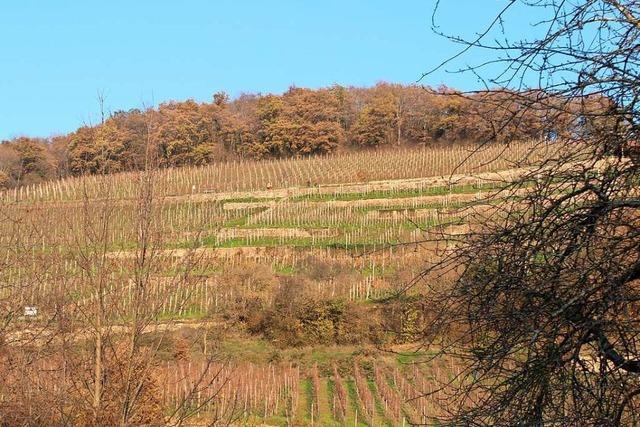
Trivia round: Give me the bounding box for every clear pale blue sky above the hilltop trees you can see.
[0,0,540,139]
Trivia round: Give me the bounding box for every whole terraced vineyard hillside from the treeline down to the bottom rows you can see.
[0,143,546,426]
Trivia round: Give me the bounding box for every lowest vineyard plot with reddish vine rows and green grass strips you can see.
[8,349,470,426]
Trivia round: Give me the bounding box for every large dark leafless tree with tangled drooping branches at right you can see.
[412,0,640,426]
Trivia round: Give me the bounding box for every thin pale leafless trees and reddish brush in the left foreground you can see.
[0,109,235,425]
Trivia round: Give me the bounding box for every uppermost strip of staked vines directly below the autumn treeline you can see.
[3,139,545,201]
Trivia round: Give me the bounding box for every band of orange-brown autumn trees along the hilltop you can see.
[0,83,584,187]
